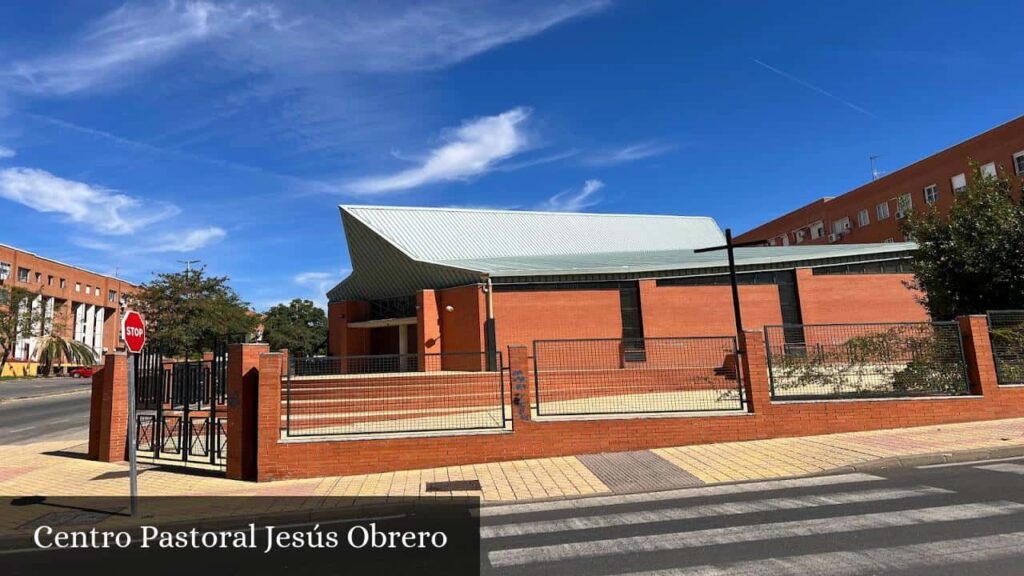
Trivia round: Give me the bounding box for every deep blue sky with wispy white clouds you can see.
[0,0,1024,310]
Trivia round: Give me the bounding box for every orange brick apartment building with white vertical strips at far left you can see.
[0,244,136,374]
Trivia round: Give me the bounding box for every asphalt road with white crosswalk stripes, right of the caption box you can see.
[481,458,1024,576]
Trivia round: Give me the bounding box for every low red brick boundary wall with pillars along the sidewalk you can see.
[243,317,1024,481]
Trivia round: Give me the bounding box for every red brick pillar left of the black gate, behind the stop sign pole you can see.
[89,353,128,462]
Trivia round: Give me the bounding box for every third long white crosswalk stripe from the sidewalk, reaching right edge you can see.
[487,501,1024,567]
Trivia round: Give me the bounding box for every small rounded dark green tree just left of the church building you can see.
[263,298,327,356]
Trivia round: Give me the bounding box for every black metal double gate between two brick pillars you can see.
[135,341,227,467]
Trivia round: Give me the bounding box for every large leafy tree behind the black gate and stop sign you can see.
[132,266,258,356]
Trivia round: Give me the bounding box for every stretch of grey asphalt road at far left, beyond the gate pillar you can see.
[0,378,91,445]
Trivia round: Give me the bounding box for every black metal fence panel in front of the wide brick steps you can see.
[282,353,511,438]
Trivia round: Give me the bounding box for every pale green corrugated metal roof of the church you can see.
[328,206,916,301]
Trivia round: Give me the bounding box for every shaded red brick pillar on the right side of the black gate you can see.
[227,343,270,480]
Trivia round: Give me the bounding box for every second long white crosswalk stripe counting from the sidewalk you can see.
[480,486,952,538]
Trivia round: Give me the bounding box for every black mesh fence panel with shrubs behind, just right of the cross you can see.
[765,322,970,400]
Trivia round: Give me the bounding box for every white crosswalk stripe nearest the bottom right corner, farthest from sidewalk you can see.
[589,532,1024,576]
